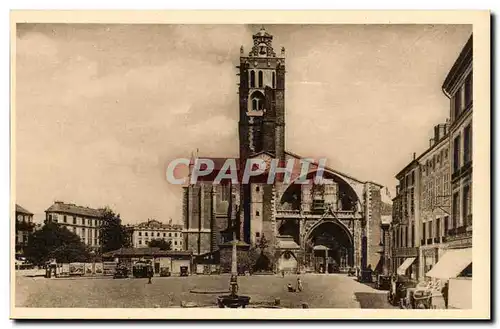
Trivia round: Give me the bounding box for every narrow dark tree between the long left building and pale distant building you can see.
[101,207,130,253]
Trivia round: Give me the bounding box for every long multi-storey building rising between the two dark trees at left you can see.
[45,201,103,249]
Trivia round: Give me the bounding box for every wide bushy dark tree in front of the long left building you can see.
[25,223,90,265]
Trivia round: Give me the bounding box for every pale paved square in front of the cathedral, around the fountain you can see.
[15,274,392,308]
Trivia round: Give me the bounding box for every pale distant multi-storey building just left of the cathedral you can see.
[132,220,184,250]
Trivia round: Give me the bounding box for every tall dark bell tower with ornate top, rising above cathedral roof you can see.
[238,27,285,161]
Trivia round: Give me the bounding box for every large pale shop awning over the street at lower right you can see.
[426,248,472,279]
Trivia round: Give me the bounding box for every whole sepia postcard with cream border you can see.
[10,11,491,320]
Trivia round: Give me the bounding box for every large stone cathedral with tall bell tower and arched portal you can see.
[183,28,390,273]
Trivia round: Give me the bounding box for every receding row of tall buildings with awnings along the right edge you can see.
[391,36,472,279]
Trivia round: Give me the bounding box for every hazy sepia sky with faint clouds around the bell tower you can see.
[13,24,472,223]
